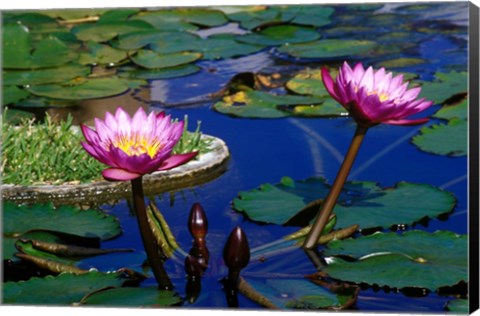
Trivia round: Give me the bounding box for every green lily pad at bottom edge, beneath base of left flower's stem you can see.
[81,287,182,307]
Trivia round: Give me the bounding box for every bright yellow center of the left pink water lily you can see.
[112,134,162,158]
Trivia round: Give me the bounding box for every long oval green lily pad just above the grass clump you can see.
[27,77,129,100]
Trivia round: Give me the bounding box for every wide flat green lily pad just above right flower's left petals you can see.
[277,39,377,59]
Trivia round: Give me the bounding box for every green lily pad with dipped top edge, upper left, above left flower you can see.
[130,50,202,69]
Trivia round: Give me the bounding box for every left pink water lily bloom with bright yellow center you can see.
[81,108,197,180]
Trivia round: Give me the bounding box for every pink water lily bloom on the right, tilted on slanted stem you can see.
[322,62,433,127]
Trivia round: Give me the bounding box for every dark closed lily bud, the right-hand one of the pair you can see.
[223,226,250,271]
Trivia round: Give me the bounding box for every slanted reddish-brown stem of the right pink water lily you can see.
[303,125,368,249]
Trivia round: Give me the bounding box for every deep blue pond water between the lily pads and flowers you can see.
[1,3,468,312]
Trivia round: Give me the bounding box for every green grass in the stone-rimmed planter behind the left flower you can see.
[0,112,209,185]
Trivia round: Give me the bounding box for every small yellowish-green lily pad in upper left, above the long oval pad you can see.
[78,41,128,66]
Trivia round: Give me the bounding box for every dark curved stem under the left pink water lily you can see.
[131,177,173,290]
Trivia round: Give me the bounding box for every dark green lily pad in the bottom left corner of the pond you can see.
[3,271,128,305]
